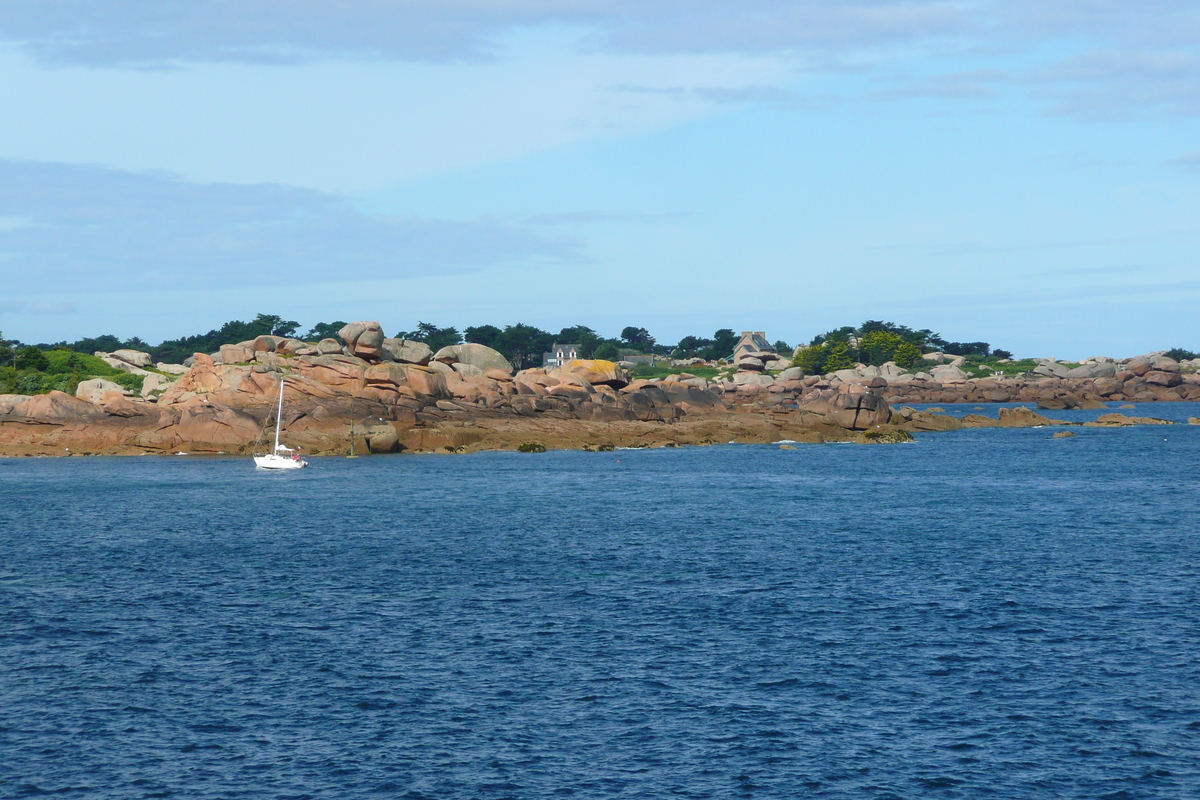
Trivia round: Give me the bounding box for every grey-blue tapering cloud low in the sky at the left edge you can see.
[0,161,584,293]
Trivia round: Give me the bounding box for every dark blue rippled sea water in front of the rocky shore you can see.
[0,404,1200,799]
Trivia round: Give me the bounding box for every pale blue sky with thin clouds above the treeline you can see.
[0,0,1200,357]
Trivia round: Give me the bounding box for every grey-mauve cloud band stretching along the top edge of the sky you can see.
[0,0,1200,119]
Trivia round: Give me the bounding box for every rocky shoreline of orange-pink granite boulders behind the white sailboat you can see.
[0,323,1185,456]
